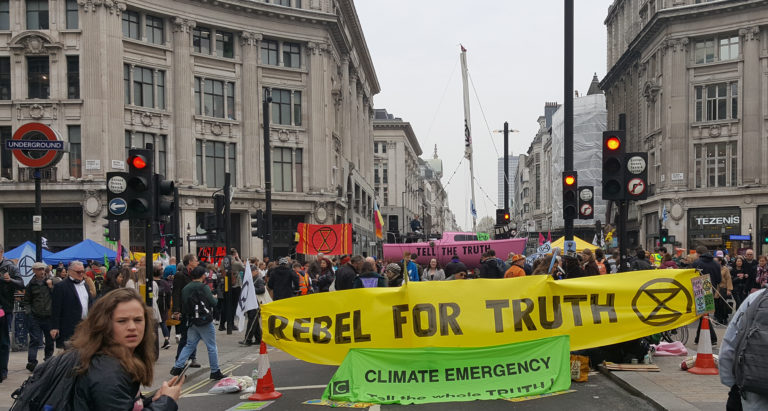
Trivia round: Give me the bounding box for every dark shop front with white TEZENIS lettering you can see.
[688,207,749,253]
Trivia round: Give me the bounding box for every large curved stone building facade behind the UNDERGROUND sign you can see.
[0,0,379,256]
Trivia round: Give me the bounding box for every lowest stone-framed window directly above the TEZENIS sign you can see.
[694,142,738,188]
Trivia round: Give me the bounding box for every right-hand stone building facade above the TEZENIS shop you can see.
[601,0,768,254]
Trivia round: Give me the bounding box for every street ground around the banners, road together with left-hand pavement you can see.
[0,332,654,411]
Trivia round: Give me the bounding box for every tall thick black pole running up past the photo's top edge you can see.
[560,0,574,241]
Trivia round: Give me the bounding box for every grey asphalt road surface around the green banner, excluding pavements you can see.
[179,346,654,411]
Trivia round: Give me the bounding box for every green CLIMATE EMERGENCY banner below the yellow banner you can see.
[323,335,571,404]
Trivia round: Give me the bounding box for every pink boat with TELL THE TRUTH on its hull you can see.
[383,232,526,268]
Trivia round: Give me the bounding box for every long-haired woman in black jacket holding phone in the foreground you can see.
[72,288,184,411]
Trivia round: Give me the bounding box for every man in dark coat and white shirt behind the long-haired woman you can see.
[51,261,93,348]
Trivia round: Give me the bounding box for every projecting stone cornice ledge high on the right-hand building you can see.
[600,0,768,90]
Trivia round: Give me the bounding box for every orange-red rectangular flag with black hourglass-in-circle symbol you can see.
[296,223,352,255]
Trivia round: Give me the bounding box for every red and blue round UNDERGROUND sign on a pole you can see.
[6,123,65,168]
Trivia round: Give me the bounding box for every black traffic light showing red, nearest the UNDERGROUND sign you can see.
[125,148,154,220]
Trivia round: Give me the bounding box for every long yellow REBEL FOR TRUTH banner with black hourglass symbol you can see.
[261,269,698,364]
